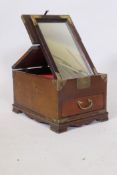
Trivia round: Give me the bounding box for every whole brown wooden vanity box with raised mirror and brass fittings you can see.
[12,15,108,133]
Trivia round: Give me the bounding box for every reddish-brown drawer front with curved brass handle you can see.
[62,94,104,117]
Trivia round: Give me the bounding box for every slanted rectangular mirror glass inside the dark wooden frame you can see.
[38,22,93,79]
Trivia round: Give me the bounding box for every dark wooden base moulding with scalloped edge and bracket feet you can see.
[13,105,108,133]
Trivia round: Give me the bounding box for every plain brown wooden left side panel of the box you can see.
[13,71,58,119]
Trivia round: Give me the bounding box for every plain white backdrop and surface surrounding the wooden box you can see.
[0,0,117,175]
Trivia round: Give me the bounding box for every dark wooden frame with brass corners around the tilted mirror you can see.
[22,15,97,79]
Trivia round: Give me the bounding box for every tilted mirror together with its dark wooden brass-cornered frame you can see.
[22,14,97,79]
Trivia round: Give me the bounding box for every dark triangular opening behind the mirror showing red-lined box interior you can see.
[15,47,54,78]
